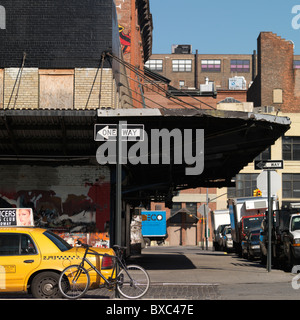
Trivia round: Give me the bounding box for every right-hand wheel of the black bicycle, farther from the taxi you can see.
[117,265,150,299]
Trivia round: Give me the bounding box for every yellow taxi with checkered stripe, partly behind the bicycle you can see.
[0,227,114,299]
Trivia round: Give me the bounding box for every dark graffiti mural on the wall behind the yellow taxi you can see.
[0,167,110,246]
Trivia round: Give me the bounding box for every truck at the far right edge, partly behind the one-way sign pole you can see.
[260,204,300,269]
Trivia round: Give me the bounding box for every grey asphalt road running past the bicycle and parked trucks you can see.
[0,247,300,301]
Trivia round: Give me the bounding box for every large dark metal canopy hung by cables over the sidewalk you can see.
[0,109,290,202]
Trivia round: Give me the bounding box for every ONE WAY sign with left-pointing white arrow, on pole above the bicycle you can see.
[94,124,144,141]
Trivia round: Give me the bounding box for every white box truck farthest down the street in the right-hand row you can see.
[211,209,230,251]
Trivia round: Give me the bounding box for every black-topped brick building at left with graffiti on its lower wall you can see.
[0,0,152,245]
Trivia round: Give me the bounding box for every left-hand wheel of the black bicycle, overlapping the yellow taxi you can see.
[58,265,90,299]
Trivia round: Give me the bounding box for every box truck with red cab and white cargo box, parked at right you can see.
[228,197,277,255]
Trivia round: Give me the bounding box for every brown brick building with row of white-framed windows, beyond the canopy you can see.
[146,46,256,90]
